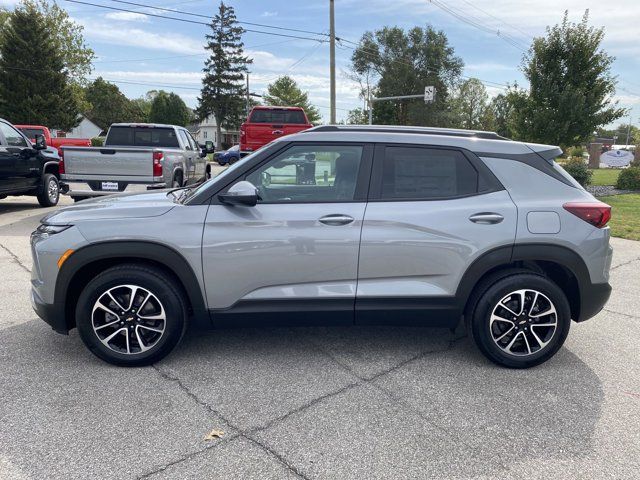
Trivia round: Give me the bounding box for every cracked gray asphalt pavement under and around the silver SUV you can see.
[0,193,640,479]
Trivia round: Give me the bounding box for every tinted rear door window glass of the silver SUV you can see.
[380,146,480,200]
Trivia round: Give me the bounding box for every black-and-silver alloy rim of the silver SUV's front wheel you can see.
[91,285,167,355]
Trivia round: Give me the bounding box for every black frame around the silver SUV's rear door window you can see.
[368,143,505,202]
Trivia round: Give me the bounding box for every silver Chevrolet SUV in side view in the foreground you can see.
[31,126,612,368]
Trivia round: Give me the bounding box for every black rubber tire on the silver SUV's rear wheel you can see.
[467,271,571,368]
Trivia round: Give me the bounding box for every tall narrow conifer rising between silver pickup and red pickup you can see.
[197,2,251,149]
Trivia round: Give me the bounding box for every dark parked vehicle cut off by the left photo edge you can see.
[0,118,60,207]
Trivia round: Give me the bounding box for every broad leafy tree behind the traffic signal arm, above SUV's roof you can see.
[351,26,464,126]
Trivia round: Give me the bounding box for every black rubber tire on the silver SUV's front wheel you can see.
[76,264,187,367]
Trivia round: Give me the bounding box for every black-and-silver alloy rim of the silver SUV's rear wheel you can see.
[489,289,558,356]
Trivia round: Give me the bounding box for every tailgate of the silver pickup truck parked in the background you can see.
[63,147,153,180]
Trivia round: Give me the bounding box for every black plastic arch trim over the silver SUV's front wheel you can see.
[49,240,211,333]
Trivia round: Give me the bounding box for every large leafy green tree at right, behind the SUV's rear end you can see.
[511,10,624,147]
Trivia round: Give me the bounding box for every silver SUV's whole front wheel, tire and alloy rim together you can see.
[76,264,187,367]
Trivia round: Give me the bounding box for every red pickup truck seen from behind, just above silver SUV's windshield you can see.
[240,106,313,154]
